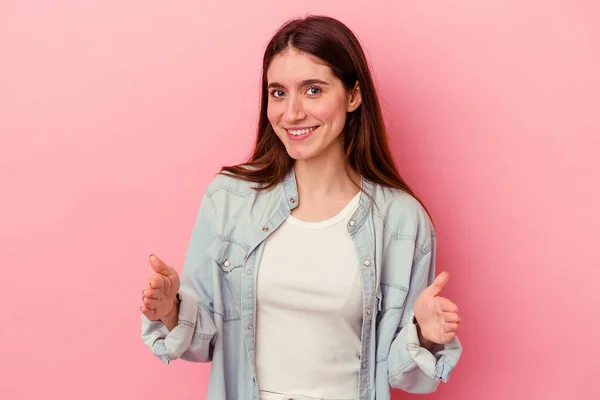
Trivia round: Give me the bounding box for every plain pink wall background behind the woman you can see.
[0,0,600,400]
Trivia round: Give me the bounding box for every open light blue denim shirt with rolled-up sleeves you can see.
[142,170,462,400]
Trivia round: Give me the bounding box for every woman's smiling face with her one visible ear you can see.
[267,49,360,161]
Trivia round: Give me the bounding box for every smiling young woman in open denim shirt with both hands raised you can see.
[141,16,462,400]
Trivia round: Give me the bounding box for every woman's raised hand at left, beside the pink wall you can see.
[140,254,179,321]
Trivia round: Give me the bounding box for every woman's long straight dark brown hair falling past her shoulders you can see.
[222,16,428,216]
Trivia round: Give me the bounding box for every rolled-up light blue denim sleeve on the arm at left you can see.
[141,191,217,364]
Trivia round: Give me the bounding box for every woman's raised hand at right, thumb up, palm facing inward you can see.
[414,272,461,344]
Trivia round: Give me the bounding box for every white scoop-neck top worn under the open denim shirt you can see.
[256,193,363,399]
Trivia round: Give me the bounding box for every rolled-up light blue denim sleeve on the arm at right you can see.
[388,231,462,393]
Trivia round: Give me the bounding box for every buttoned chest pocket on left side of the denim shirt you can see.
[207,238,246,321]
